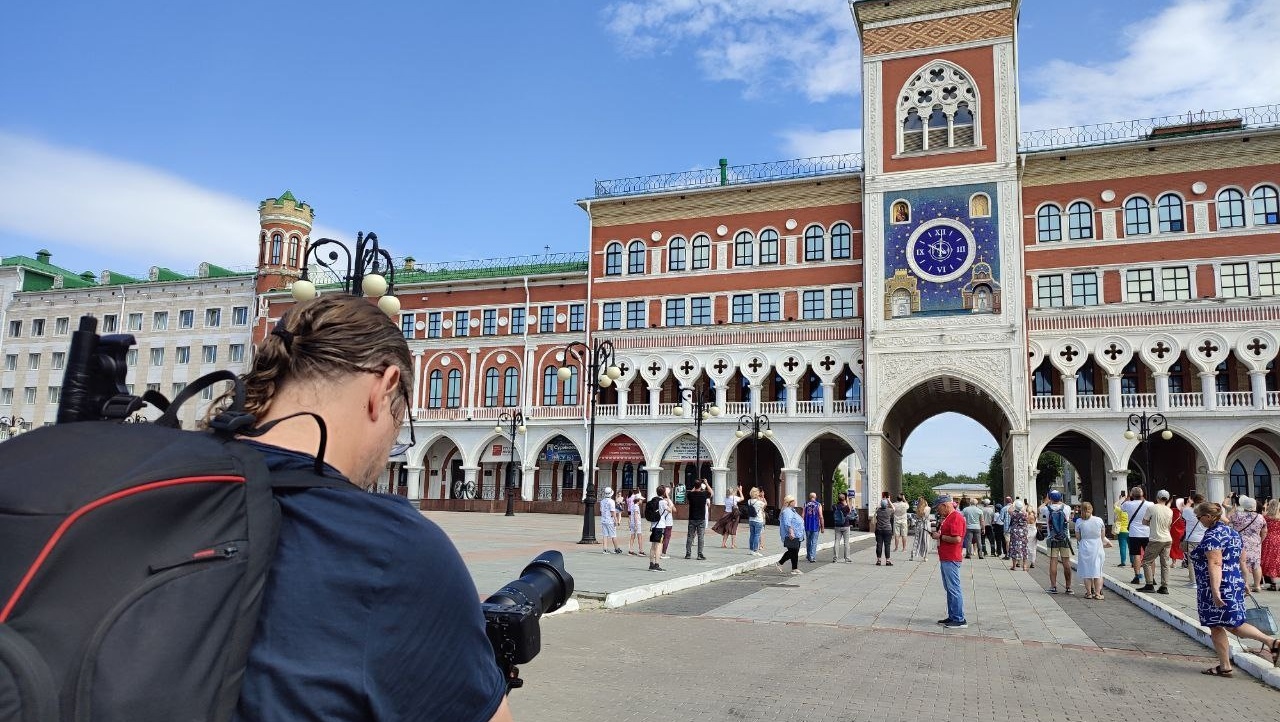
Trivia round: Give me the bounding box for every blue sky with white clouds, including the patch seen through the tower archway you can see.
[0,0,1280,471]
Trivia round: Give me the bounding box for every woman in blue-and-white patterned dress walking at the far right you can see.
[1190,502,1280,677]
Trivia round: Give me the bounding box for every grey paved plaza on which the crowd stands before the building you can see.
[428,512,1280,721]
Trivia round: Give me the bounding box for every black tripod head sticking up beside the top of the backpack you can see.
[58,316,143,424]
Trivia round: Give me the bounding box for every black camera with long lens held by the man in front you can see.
[480,550,573,691]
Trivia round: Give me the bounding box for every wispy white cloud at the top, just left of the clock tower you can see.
[604,0,859,101]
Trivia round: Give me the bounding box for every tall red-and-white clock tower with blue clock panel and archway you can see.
[850,0,1034,503]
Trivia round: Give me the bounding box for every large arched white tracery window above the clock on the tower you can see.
[897,60,979,154]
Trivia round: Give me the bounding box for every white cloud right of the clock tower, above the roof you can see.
[1021,0,1280,129]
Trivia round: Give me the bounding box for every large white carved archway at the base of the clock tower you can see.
[860,373,1033,506]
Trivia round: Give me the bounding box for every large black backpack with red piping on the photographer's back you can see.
[0,371,356,722]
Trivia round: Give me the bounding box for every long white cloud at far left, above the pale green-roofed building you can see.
[0,131,343,271]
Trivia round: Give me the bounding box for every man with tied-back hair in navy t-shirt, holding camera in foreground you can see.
[236,294,511,722]
